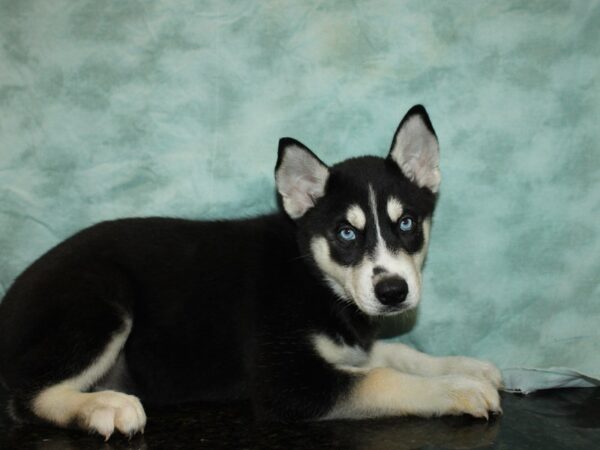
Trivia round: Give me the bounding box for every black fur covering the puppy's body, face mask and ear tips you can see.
[0,108,436,426]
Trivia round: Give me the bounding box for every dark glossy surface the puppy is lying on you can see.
[0,388,600,450]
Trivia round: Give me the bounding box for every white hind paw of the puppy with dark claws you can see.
[77,391,146,440]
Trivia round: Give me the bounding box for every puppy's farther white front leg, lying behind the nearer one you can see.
[367,342,502,389]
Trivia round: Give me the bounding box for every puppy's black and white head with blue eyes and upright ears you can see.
[275,105,440,315]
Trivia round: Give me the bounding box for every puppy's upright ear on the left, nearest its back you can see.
[275,138,329,219]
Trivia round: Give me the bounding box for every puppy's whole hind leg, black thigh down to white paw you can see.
[0,268,146,439]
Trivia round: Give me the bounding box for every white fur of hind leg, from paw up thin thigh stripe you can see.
[32,319,146,439]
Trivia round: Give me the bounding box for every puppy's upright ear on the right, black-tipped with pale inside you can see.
[388,105,441,193]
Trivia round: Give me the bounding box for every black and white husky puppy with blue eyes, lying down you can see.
[0,106,501,439]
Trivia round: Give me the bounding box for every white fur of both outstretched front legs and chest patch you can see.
[312,334,502,419]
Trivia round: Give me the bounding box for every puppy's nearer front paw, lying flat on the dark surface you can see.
[439,375,502,419]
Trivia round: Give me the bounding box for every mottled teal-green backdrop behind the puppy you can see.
[0,0,600,388]
